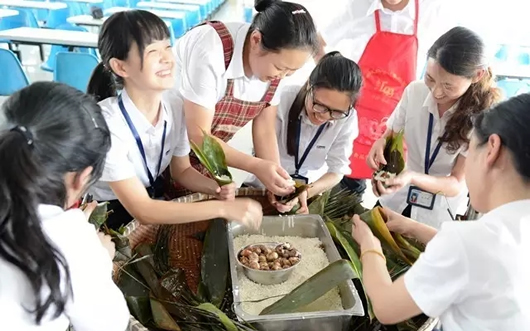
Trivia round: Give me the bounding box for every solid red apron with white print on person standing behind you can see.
[348,0,419,179]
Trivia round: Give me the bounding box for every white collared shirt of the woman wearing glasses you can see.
[246,86,359,186]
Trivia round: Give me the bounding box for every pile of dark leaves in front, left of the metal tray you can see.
[117,219,254,331]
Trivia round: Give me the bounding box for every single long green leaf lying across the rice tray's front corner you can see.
[260,260,357,315]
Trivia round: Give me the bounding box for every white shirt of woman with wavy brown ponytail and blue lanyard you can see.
[379,81,467,228]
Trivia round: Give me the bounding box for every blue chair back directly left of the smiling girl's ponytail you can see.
[53,52,99,92]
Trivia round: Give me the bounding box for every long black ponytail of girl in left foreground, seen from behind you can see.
[0,130,72,324]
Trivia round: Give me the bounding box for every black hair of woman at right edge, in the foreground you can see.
[473,93,530,183]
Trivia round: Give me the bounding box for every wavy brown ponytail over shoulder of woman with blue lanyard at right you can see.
[440,68,501,153]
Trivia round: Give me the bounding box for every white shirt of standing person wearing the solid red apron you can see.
[285,0,458,84]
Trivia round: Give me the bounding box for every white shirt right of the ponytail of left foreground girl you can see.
[46,209,130,331]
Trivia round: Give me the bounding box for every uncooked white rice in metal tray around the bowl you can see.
[234,235,344,315]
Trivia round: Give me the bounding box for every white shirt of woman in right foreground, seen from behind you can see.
[405,200,530,331]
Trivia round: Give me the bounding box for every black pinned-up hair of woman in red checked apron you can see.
[248,0,319,54]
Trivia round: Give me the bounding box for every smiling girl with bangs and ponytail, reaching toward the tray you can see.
[84,10,261,233]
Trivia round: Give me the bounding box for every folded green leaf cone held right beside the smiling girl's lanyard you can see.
[190,130,232,186]
